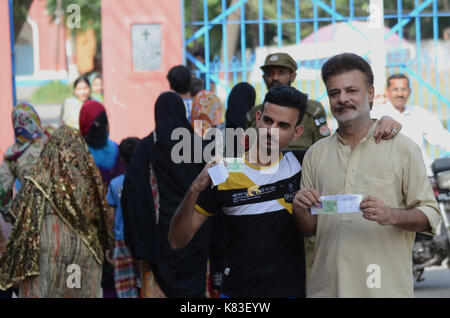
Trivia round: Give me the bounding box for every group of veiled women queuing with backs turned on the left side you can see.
[0,75,243,297]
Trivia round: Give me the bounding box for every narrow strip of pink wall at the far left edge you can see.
[0,1,14,162]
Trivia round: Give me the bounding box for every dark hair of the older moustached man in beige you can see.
[322,53,373,87]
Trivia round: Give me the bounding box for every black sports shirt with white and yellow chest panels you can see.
[196,152,305,297]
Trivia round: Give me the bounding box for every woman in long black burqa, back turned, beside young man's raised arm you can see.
[121,92,211,297]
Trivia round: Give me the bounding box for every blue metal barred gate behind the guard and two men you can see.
[181,0,450,157]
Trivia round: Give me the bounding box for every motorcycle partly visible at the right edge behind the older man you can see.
[413,156,450,282]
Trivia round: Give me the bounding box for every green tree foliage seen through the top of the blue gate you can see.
[184,0,450,56]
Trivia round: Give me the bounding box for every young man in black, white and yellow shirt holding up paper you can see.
[169,86,307,297]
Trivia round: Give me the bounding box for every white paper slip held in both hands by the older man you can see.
[311,194,363,214]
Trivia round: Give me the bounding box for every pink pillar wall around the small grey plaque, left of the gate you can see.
[101,0,183,142]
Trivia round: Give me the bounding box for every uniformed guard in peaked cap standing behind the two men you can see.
[247,53,330,284]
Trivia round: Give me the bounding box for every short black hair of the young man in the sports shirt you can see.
[261,86,308,126]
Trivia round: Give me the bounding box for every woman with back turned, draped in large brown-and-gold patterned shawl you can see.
[0,126,113,297]
